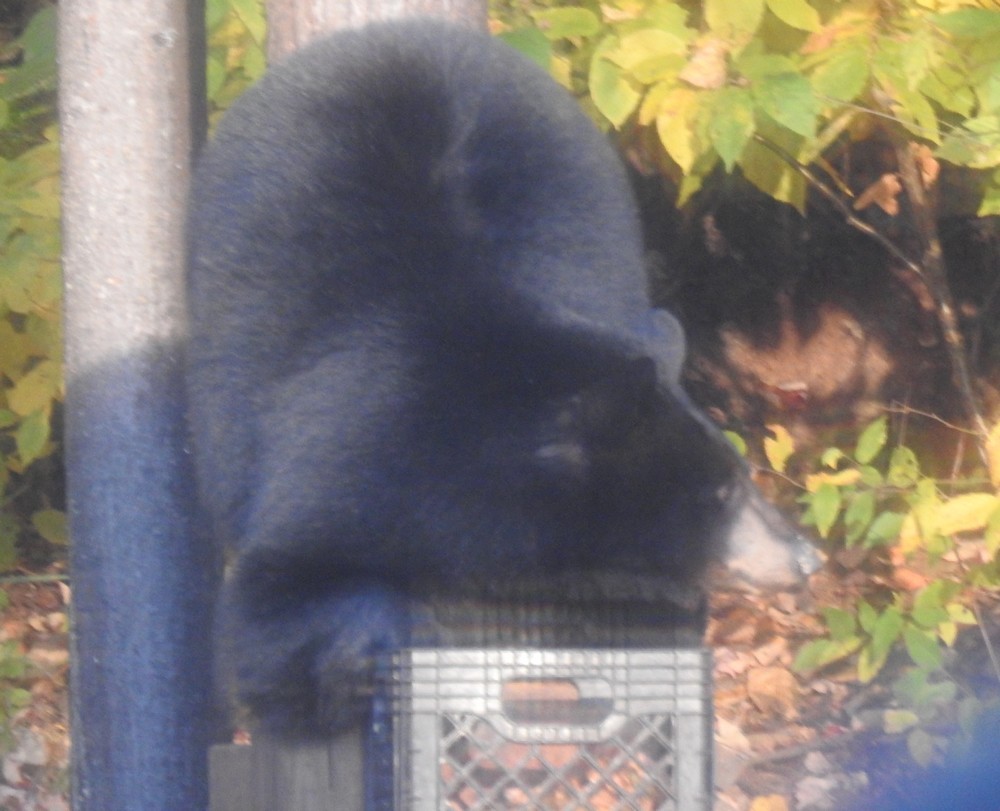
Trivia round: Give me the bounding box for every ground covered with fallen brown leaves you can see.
[0,566,1000,811]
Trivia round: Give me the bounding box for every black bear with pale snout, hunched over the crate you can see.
[188,15,814,734]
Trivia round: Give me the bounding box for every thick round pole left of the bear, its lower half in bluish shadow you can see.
[59,0,215,811]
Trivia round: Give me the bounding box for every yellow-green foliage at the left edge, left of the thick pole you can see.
[0,7,66,571]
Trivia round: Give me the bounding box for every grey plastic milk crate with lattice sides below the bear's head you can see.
[378,648,712,811]
